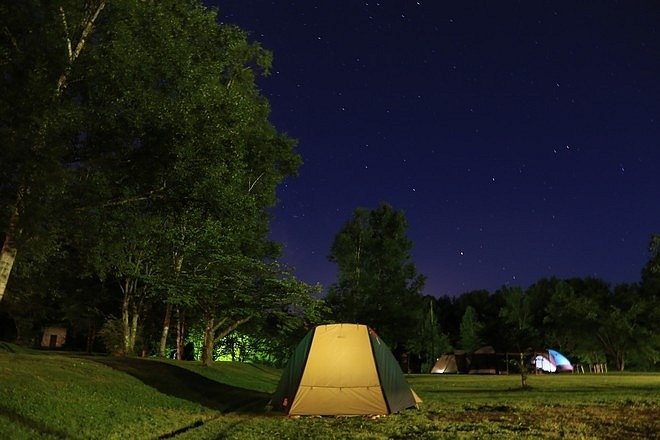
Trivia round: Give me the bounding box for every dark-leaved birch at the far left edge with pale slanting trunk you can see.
[0,0,106,300]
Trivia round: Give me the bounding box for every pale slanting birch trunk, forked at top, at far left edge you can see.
[0,0,106,301]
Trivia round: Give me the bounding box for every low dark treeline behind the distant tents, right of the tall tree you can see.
[418,272,660,371]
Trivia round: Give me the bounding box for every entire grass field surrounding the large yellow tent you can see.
[0,342,660,439]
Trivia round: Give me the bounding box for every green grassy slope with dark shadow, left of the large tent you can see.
[0,343,279,440]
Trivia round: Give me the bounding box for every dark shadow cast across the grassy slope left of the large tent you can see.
[85,357,270,414]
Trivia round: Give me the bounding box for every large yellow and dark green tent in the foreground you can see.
[271,324,420,415]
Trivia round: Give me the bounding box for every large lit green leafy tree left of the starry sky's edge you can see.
[79,2,300,354]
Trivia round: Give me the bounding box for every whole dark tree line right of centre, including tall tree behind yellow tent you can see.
[326,204,660,372]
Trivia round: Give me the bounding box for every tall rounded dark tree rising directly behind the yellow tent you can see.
[326,203,424,348]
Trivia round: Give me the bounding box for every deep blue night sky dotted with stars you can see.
[204,0,660,296]
